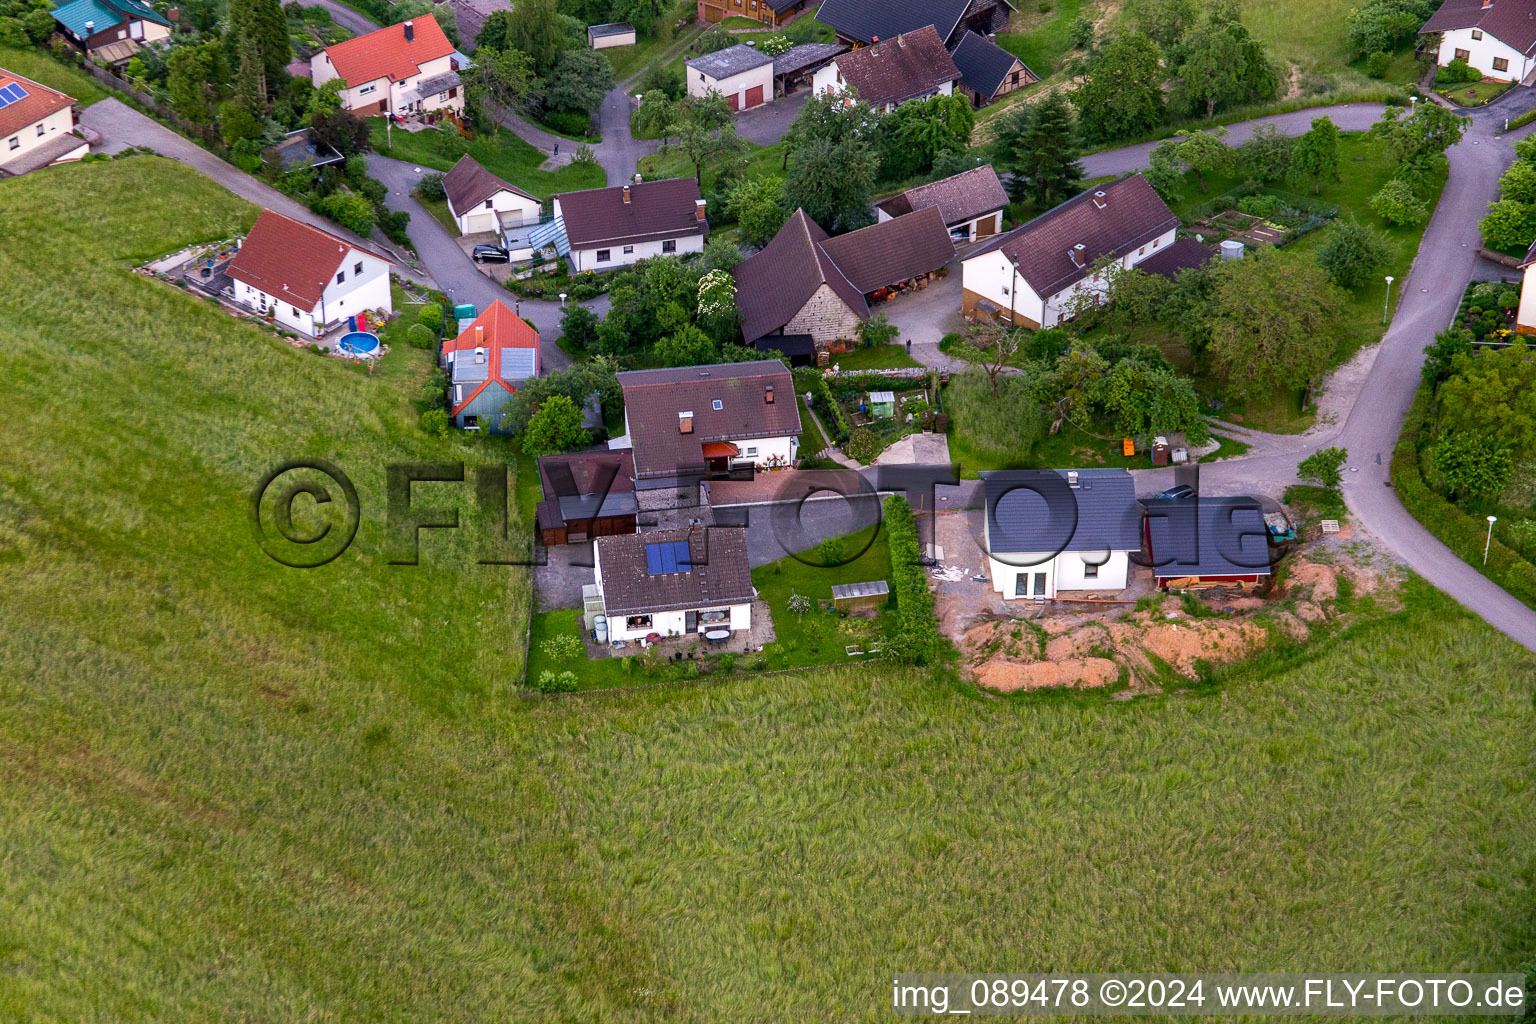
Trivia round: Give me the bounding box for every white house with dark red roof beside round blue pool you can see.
[224,210,395,338]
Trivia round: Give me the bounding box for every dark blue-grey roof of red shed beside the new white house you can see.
[1143,496,1272,579]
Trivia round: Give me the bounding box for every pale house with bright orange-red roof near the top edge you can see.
[309,14,464,117]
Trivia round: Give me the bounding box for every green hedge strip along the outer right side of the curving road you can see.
[1394,387,1536,608]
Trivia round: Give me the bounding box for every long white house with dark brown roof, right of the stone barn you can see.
[962,173,1178,327]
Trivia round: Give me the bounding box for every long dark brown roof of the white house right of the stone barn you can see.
[966,173,1178,298]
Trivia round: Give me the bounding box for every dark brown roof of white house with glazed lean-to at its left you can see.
[554,178,710,249]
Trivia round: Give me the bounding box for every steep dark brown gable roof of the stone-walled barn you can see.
[731,210,869,343]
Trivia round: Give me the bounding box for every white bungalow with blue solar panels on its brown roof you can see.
[593,527,757,640]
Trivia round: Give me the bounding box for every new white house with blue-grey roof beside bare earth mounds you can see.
[982,470,1142,600]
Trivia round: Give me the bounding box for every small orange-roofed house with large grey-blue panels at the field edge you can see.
[442,299,539,433]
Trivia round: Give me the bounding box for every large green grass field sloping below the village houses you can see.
[0,164,1536,1022]
